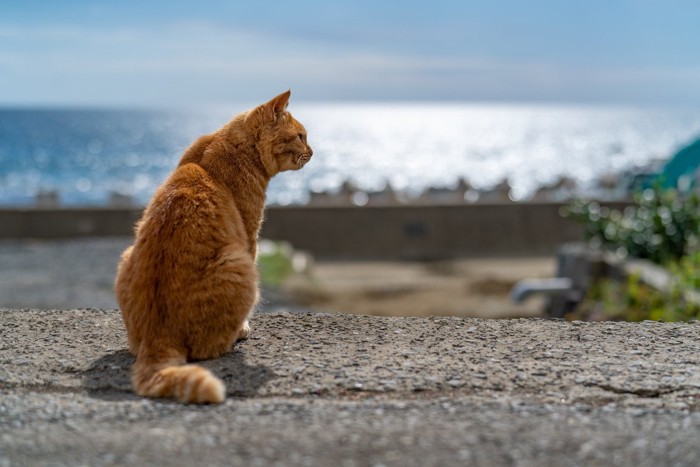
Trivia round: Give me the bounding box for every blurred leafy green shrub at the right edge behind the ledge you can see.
[565,186,700,321]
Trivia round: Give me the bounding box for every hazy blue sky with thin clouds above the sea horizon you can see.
[0,0,700,107]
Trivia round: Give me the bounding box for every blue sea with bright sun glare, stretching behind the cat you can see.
[0,102,700,206]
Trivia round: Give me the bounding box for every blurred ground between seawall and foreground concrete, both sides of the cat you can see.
[0,237,555,318]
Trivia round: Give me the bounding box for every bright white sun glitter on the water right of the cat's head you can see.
[276,104,700,199]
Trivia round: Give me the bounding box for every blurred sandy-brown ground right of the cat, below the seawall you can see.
[285,257,556,318]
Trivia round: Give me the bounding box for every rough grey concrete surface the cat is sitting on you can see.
[0,309,700,466]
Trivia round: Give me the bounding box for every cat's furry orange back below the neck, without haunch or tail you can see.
[115,164,245,354]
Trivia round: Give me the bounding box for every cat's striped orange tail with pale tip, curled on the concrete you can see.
[131,351,226,404]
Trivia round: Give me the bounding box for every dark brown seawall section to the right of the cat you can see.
[262,203,581,260]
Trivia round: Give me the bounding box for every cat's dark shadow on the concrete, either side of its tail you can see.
[83,348,276,400]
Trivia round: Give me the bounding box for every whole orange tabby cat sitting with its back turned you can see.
[115,91,312,403]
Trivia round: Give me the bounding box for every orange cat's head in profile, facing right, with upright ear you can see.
[249,91,313,175]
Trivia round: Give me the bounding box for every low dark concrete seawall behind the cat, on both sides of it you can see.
[0,203,621,260]
